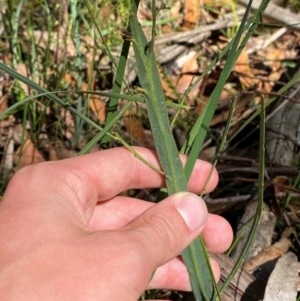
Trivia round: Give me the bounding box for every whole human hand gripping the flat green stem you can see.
[0,147,232,301]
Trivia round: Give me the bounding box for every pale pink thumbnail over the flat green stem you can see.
[175,192,207,231]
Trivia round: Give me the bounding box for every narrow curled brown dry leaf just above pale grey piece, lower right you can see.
[243,237,291,272]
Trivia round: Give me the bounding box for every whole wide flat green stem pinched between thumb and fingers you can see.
[129,2,215,301]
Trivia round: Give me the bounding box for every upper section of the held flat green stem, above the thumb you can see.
[129,15,183,194]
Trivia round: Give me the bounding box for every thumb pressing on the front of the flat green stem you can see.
[124,192,208,273]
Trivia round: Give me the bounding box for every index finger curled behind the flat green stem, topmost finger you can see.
[61,147,218,201]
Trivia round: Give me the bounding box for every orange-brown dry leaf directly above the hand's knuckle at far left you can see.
[14,138,45,168]
